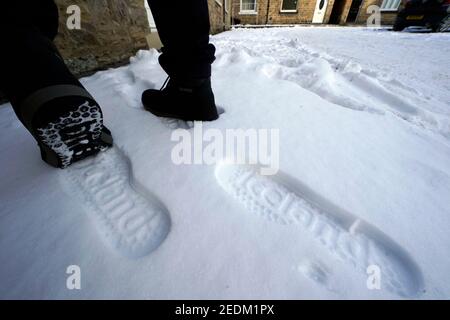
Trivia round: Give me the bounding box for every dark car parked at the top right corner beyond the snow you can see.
[394,0,450,31]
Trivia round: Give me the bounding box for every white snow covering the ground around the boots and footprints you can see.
[0,27,450,299]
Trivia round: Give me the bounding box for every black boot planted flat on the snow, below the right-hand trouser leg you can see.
[142,78,219,121]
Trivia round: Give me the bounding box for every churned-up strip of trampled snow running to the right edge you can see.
[216,38,450,137]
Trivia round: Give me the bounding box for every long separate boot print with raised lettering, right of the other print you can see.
[216,164,422,297]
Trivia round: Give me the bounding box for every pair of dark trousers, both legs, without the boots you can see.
[0,0,215,124]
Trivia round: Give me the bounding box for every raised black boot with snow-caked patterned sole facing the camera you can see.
[21,88,113,169]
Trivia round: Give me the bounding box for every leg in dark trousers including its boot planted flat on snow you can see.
[142,0,218,121]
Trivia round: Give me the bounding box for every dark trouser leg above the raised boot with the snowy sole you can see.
[0,0,81,124]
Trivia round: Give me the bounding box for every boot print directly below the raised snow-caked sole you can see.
[61,147,170,258]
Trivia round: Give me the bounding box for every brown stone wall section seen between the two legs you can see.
[55,0,150,76]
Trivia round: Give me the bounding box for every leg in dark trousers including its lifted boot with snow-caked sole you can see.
[0,0,111,167]
